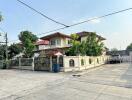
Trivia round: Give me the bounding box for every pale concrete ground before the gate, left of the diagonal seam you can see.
[0,70,65,100]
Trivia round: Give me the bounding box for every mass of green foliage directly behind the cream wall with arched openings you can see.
[67,33,104,56]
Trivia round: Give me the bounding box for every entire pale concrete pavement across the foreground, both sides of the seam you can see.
[0,64,132,100]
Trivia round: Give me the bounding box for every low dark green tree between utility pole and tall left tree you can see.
[8,44,23,59]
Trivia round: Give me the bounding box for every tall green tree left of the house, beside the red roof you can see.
[19,31,38,57]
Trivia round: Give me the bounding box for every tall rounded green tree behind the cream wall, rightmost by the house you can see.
[85,33,104,56]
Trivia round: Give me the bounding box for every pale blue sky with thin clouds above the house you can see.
[0,0,132,50]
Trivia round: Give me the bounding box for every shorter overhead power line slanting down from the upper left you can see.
[17,0,68,27]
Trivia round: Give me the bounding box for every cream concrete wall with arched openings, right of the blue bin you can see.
[61,56,110,72]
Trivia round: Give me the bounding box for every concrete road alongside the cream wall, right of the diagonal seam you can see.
[2,64,132,100]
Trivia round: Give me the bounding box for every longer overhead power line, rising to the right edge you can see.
[8,8,132,42]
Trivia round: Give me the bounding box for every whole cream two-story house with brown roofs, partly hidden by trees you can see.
[37,31,105,56]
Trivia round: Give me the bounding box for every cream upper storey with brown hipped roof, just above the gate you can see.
[38,32,71,56]
